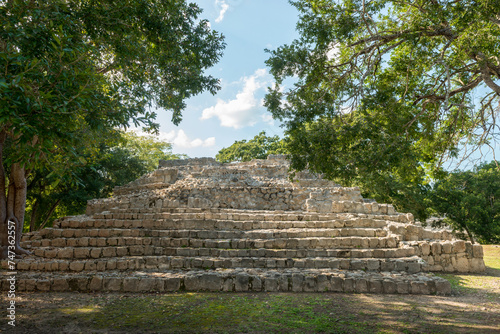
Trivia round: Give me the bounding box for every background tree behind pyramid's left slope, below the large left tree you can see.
[26,131,184,231]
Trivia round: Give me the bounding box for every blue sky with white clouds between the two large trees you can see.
[142,0,298,158]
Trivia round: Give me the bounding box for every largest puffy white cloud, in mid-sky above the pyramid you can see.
[201,69,267,129]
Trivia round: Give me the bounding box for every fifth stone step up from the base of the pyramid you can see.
[54,215,388,230]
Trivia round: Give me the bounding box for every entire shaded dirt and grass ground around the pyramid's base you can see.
[0,246,500,334]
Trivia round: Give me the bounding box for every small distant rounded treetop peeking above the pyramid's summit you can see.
[216,131,288,162]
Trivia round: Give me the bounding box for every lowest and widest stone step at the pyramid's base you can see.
[1,269,451,295]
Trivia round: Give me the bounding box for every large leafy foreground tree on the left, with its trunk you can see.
[0,0,224,256]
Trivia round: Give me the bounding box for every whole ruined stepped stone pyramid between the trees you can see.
[2,156,485,294]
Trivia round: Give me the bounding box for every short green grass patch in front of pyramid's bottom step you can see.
[82,293,372,333]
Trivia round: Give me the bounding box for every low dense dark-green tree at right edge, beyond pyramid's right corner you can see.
[431,162,500,243]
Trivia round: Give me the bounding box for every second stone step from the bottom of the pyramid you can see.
[6,256,425,273]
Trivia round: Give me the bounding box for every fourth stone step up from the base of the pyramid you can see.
[28,227,388,240]
